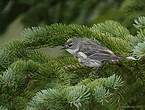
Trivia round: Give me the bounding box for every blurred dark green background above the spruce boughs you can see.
[0,0,145,46]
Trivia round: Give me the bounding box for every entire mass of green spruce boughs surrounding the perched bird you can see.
[0,17,145,110]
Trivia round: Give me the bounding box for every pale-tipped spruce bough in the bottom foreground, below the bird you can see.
[27,75,122,110]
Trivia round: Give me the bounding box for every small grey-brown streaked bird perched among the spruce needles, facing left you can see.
[64,38,135,68]
